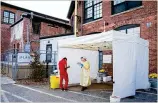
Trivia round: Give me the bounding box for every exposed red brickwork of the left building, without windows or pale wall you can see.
[1,6,70,52]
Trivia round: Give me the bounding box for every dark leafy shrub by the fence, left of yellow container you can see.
[30,52,46,82]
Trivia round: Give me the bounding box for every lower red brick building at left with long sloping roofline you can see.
[1,2,71,53]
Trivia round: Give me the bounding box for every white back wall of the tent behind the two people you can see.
[58,48,99,84]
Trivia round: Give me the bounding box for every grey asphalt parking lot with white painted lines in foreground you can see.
[1,76,157,102]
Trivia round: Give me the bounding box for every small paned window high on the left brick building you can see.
[3,11,15,24]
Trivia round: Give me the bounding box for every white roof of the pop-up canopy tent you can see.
[58,30,148,50]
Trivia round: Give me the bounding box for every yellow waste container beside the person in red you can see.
[50,75,60,89]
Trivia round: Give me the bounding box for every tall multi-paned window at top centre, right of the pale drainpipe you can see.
[84,0,102,23]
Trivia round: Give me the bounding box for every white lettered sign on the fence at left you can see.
[18,53,32,63]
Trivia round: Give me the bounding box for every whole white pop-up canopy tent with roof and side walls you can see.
[58,30,149,98]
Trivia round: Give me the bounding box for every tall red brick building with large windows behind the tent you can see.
[67,0,157,73]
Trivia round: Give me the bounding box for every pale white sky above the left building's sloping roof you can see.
[3,0,71,20]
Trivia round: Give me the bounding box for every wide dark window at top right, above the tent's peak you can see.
[111,0,142,14]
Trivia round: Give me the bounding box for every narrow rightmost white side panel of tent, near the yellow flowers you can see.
[136,39,150,89]
